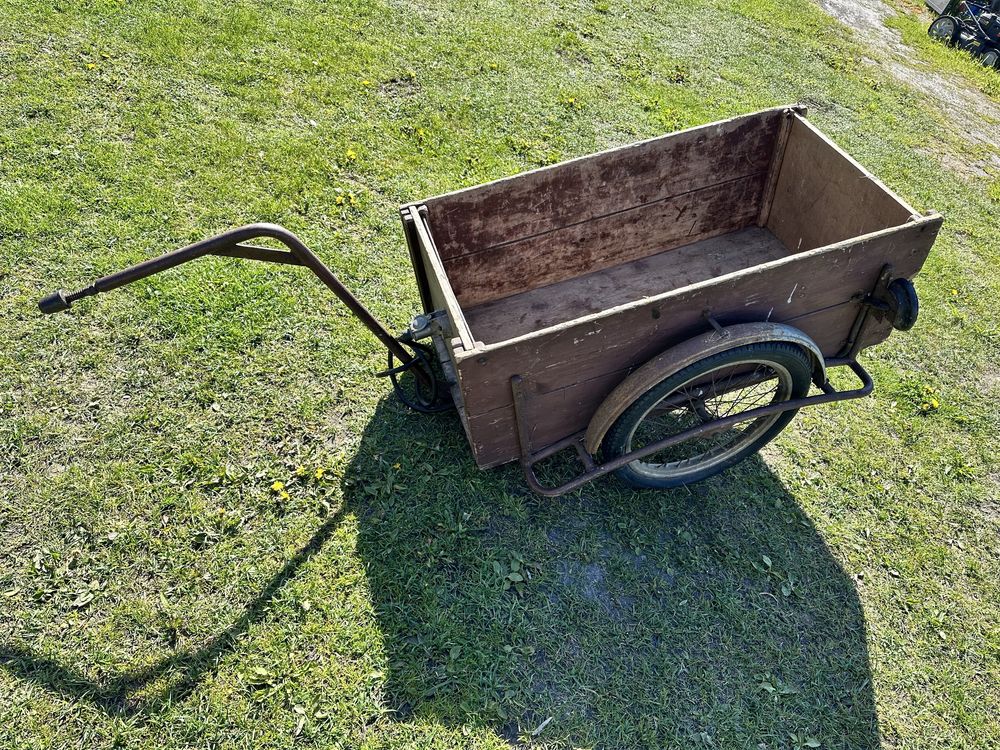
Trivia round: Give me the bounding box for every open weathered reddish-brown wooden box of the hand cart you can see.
[402,107,941,468]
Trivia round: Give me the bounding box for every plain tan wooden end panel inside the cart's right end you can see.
[767,115,915,252]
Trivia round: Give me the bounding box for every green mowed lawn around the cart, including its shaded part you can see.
[0,0,1000,749]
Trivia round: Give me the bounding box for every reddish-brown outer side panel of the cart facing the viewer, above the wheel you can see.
[458,216,941,466]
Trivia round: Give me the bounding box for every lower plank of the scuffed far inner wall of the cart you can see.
[446,171,767,308]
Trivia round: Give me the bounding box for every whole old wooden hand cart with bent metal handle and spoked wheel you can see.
[39,107,942,495]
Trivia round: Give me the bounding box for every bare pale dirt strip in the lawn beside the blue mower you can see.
[816,0,1000,151]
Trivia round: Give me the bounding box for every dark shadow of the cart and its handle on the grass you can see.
[0,399,879,748]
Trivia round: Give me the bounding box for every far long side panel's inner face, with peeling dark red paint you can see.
[425,109,784,305]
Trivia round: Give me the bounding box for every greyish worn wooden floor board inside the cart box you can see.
[465,227,789,344]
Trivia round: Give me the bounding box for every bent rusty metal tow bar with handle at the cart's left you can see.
[38,223,436,394]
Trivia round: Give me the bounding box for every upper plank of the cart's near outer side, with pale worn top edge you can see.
[457,215,941,428]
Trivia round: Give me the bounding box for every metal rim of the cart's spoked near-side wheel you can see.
[626,358,793,480]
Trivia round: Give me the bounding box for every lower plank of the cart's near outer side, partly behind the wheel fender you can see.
[469,302,892,469]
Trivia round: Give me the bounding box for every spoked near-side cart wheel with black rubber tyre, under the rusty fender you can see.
[602,342,812,488]
